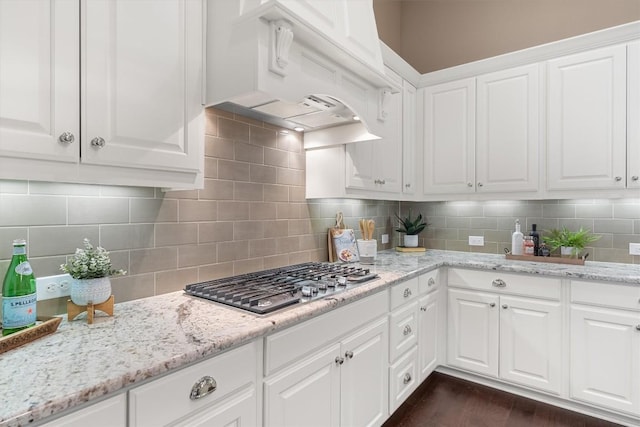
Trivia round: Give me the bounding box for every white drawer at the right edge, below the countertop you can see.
[571,280,640,311]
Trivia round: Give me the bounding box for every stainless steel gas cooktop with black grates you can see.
[185,262,378,314]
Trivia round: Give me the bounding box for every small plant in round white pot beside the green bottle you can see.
[60,239,127,305]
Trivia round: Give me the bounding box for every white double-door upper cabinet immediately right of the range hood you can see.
[346,67,403,195]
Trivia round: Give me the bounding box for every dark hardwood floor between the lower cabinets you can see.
[383,372,618,427]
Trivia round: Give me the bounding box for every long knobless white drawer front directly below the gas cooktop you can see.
[264,292,389,375]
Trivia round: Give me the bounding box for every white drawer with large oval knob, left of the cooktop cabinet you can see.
[129,340,261,427]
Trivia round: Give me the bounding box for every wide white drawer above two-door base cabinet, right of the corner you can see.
[448,268,561,301]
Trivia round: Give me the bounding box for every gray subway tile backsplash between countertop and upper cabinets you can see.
[0,109,640,312]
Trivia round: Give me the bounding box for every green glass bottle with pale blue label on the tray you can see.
[2,239,36,336]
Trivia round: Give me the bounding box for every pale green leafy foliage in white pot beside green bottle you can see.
[60,239,127,279]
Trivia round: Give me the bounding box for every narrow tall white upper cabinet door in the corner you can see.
[402,81,418,194]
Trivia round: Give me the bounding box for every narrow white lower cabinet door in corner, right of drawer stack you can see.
[418,291,440,380]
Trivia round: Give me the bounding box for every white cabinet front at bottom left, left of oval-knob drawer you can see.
[41,393,127,427]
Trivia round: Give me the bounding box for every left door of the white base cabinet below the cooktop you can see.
[264,343,342,427]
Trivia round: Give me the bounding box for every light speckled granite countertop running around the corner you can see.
[0,250,640,426]
